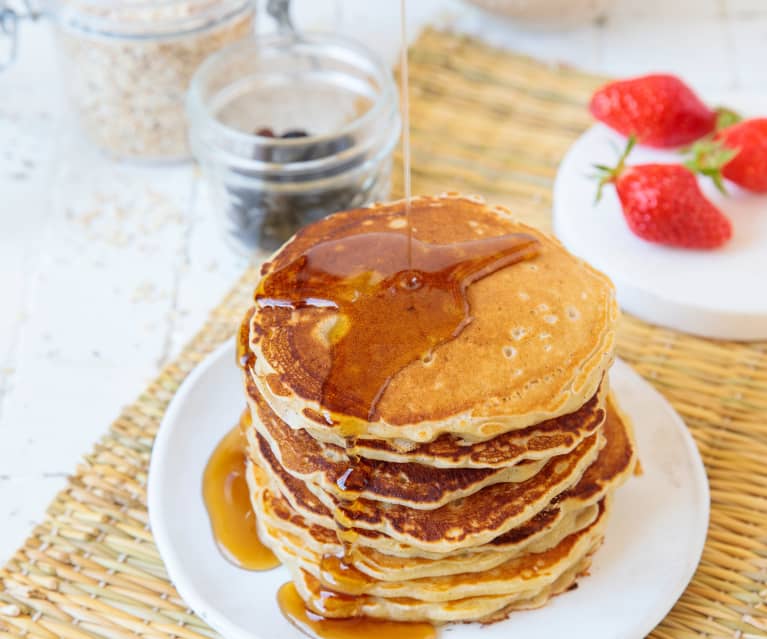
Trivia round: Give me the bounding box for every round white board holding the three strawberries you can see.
[554,96,767,340]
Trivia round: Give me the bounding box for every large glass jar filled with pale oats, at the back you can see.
[49,0,255,162]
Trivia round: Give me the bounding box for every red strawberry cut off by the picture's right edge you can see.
[716,118,767,193]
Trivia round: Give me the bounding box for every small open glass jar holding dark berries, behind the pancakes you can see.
[187,34,400,252]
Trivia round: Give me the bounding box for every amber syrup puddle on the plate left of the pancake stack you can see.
[202,426,280,570]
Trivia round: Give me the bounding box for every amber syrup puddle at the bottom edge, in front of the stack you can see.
[277,582,437,639]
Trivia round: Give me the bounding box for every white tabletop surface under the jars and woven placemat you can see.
[0,0,767,563]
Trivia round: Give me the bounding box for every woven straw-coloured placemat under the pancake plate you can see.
[0,30,767,639]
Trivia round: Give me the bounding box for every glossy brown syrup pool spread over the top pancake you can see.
[256,230,538,421]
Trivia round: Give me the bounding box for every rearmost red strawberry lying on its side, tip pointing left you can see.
[589,74,717,148]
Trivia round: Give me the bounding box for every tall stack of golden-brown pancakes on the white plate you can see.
[239,196,636,623]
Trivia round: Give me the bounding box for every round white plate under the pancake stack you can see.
[149,342,709,639]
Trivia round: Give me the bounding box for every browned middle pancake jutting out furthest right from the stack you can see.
[246,390,636,558]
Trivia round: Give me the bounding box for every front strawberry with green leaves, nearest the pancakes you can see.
[596,138,732,249]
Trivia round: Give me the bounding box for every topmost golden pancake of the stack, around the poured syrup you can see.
[245,196,618,445]
